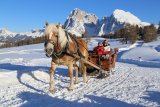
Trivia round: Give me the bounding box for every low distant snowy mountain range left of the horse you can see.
[0,28,44,42]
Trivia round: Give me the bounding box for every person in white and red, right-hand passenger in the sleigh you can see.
[103,40,111,59]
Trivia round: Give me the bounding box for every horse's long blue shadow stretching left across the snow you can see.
[0,63,68,93]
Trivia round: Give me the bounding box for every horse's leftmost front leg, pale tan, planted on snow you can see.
[50,62,57,93]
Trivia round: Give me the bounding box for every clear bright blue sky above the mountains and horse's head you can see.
[0,0,160,32]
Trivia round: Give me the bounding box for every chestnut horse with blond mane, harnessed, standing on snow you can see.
[44,23,88,93]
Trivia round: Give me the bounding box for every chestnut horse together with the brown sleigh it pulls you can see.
[44,23,117,93]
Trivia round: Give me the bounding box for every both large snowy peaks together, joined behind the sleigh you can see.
[64,8,150,36]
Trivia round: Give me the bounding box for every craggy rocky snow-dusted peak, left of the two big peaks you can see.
[64,8,98,36]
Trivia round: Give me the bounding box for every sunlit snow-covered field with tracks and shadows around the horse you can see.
[0,38,160,107]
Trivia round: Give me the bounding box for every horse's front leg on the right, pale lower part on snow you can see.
[68,64,74,90]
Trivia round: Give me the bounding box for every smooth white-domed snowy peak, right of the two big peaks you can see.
[97,9,150,36]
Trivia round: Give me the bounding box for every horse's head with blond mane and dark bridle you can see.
[44,23,65,57]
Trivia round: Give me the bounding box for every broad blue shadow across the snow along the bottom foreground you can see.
[18,92,143,107]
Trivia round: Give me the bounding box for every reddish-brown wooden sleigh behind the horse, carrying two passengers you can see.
[87,48,118,78]
